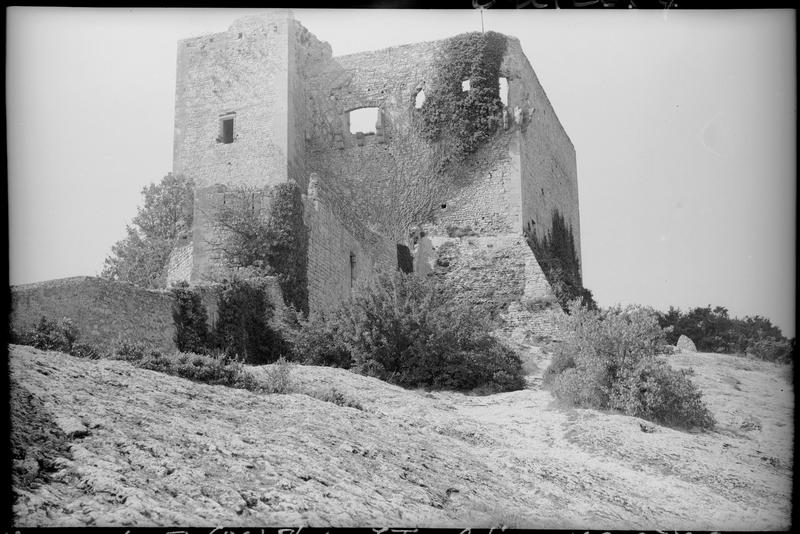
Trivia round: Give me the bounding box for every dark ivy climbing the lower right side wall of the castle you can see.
[525,210,597,311]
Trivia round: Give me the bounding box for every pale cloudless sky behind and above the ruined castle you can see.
[6,8,797,336]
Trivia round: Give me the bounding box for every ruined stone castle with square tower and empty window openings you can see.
[169,10,580,330]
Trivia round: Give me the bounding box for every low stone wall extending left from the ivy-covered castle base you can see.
[11,276,175,350]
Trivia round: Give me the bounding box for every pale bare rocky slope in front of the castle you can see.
[10,345,794,530]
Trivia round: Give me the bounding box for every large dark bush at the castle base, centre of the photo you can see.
[290,272,525,393]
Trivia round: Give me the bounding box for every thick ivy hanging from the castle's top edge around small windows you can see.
[417,32,506,164]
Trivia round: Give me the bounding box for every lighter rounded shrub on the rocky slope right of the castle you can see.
[544,301,716,429]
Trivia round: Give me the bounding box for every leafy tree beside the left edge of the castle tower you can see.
[101,173,194,288]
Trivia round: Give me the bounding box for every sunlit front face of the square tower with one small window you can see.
[173,10,291,192]
